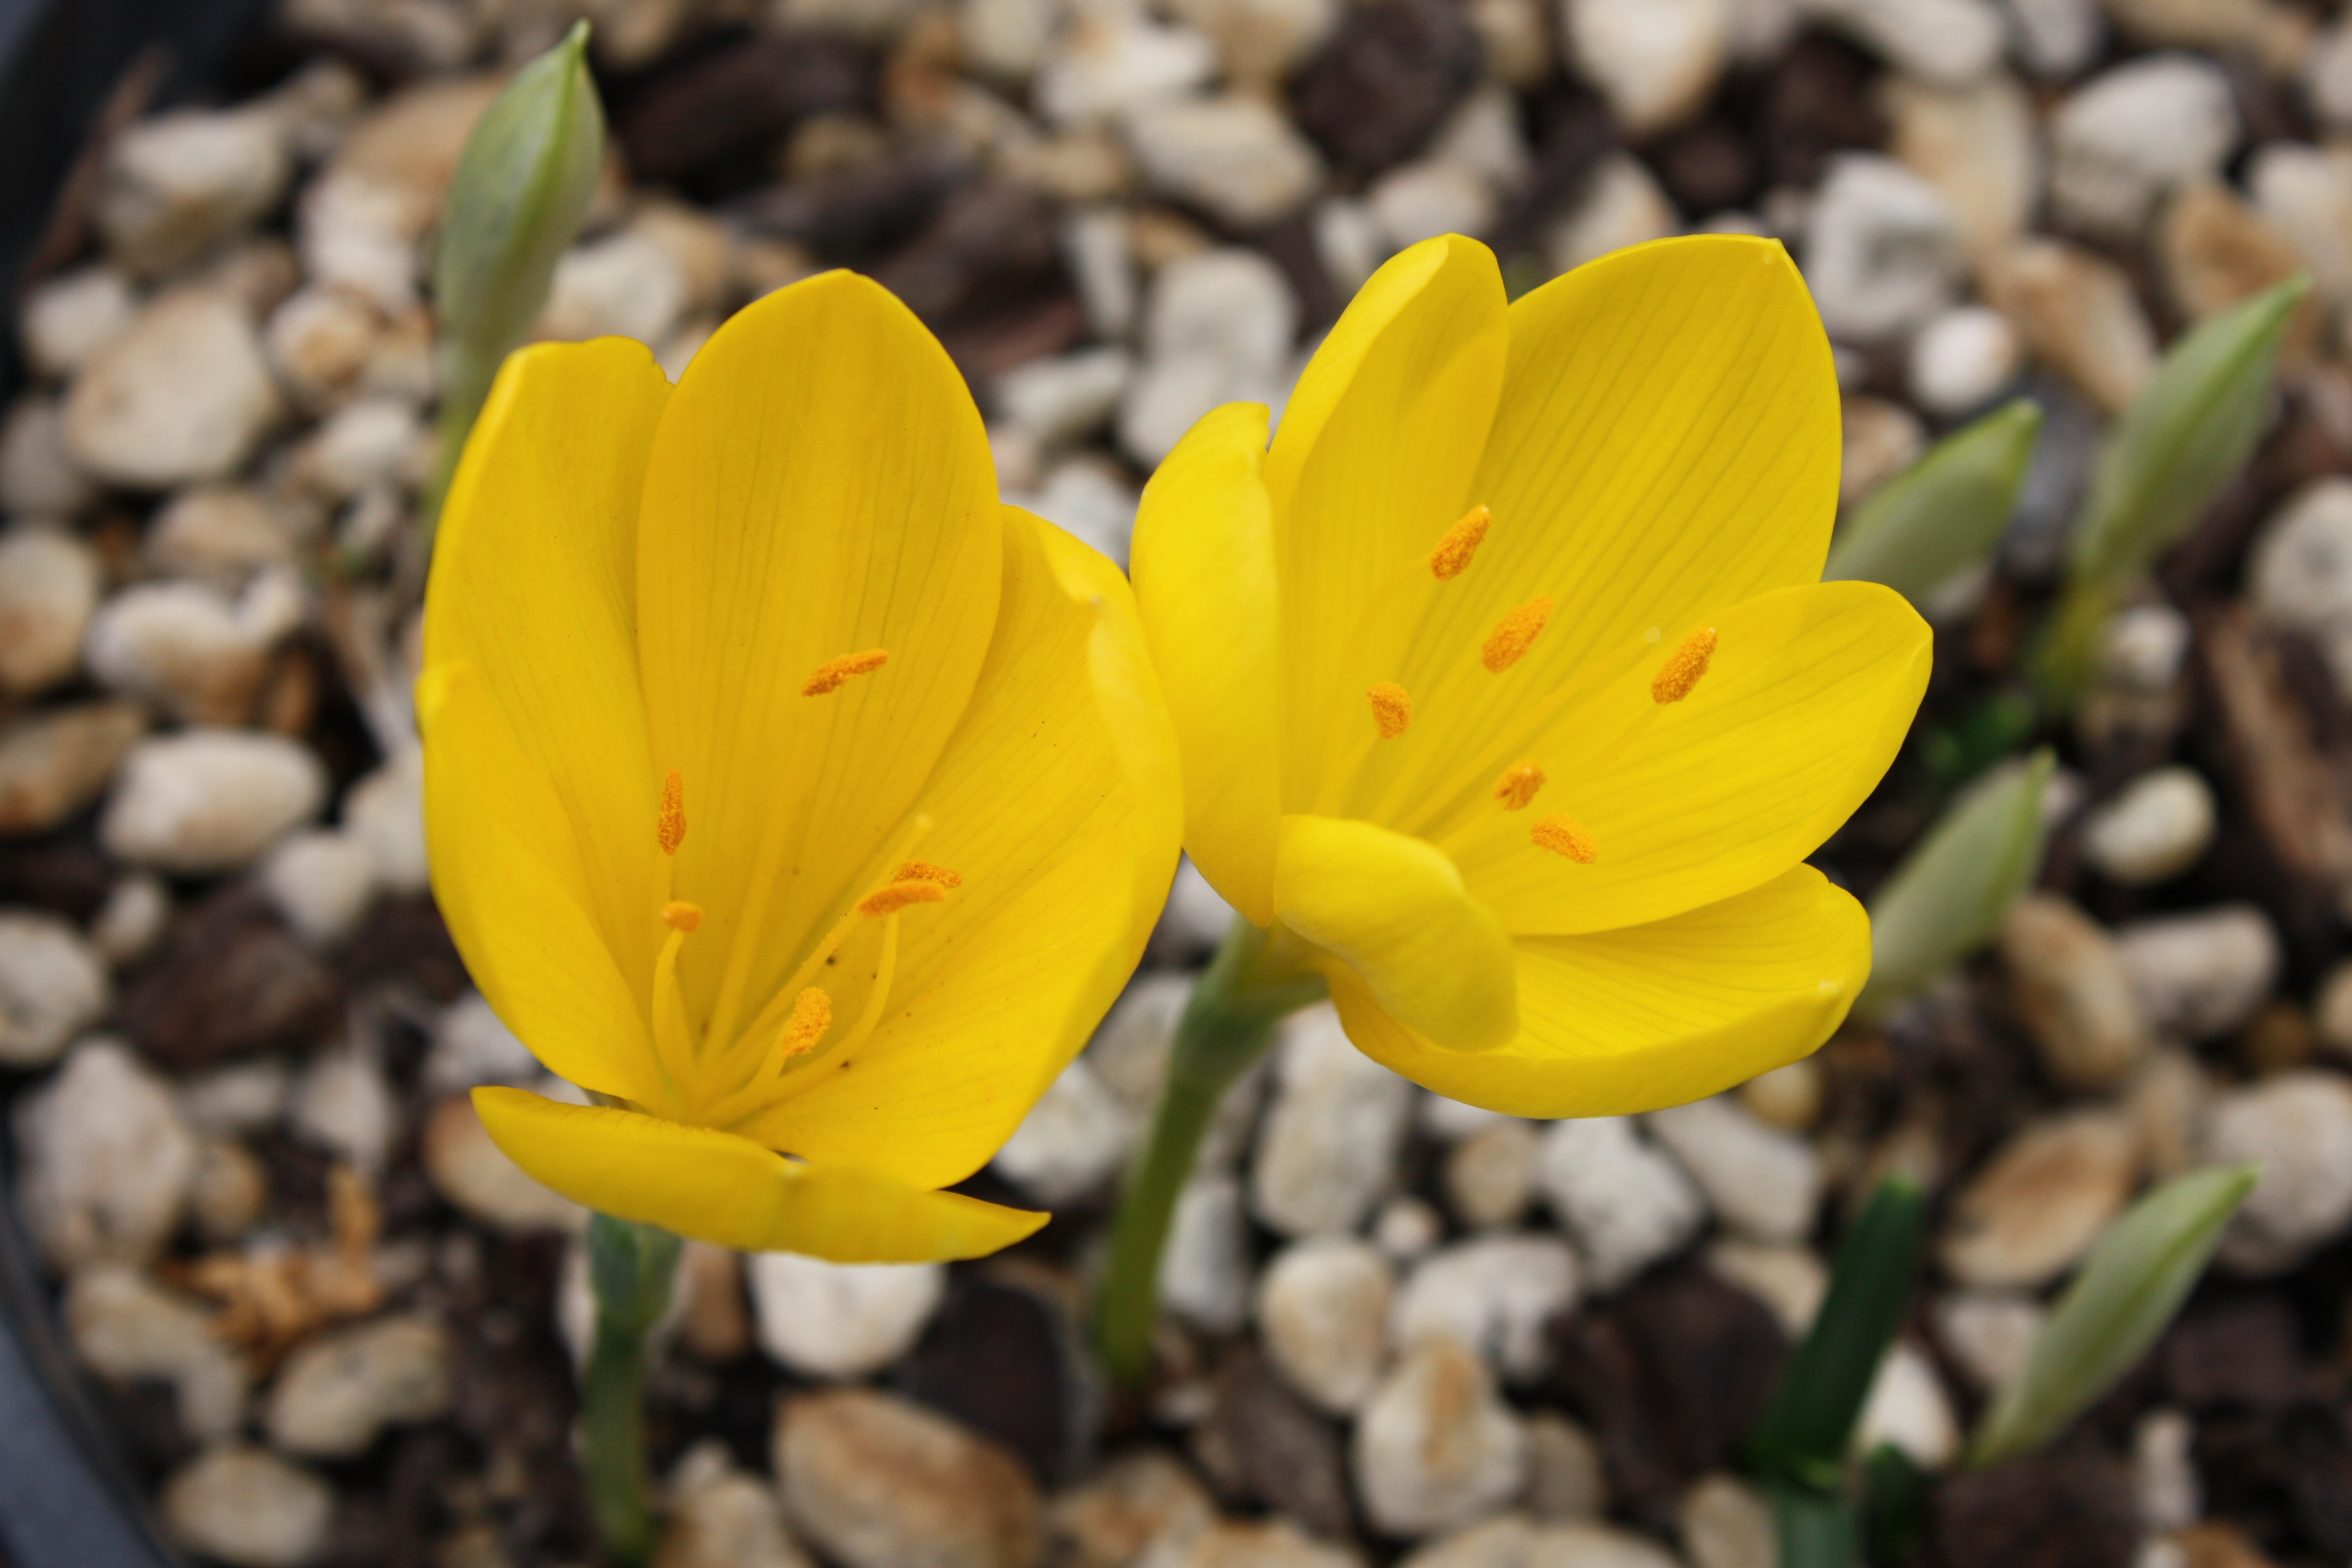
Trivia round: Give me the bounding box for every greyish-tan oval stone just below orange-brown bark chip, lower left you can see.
[263,1312,456,1460]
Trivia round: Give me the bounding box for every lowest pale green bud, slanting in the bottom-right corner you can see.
[1969,1164,2258,1467]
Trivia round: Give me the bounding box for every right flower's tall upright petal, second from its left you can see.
[1270,235,1507,811]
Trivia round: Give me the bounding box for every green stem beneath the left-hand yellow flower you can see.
[581,1213,682,1568]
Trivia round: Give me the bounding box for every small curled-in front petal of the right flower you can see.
[1275,816,1520,1051]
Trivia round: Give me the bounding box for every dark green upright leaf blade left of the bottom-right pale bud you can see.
[1747,1175,1926,1493]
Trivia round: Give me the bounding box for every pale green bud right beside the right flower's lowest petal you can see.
[1853,748,2056,1018]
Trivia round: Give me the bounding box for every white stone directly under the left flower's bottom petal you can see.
[745,1253,948,1380]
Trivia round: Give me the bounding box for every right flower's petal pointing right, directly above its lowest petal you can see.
[1439,583,1931,935]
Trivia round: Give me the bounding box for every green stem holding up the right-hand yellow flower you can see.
[1096,917,1324,1385]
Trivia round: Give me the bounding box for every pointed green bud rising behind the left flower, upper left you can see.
[433,21,605,505]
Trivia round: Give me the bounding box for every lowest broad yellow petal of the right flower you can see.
[1331,865,1870,1117]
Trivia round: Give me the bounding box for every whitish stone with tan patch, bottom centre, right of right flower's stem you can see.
[1348,1335,1527,1537]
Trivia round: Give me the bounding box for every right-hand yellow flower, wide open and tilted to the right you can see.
[1134,235,1929,1117]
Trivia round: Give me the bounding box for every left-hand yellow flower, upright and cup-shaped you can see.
[418,273,1181,1260]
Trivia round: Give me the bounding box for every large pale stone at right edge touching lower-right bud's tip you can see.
[2199,1070,2352,1274]
